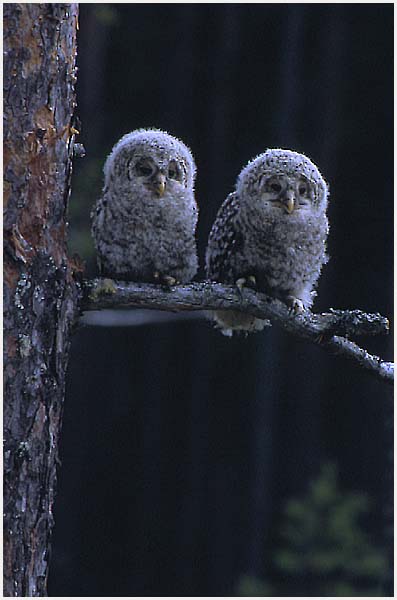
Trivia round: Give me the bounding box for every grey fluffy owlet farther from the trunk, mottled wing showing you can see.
[206,149,328,335]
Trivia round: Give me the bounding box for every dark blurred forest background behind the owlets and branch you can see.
[49,3,393,596]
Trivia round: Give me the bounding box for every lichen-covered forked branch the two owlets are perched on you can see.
[81,279,394,384]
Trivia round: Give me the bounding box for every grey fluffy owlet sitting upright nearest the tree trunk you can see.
[91,129,198,284]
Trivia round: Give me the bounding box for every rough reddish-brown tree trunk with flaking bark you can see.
[3,4,79,596]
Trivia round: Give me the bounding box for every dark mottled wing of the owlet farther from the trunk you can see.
[206,192,243,283]
